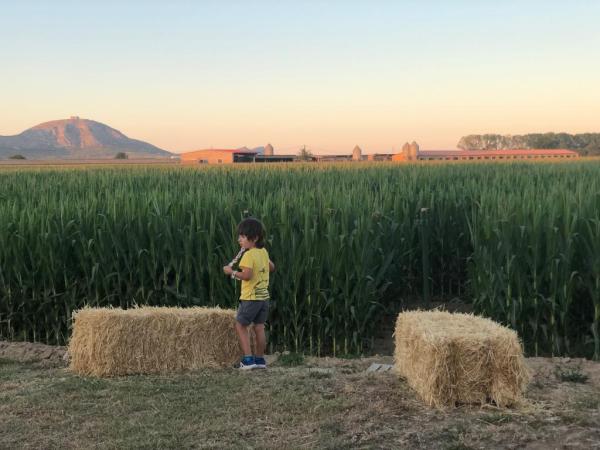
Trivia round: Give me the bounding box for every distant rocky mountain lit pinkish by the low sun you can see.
[0,117,171,159]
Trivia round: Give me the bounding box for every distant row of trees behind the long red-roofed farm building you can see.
[457,133,600,156]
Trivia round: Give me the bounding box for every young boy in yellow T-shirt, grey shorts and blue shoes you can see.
[223,217,275,370]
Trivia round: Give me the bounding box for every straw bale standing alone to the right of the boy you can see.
[394,311,530,408]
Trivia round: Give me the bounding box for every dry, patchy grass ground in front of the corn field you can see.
[0,354,600,449]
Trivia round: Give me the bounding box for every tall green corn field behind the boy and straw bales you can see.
[0,161,600,359]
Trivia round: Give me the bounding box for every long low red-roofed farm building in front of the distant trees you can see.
[392,142,579,161]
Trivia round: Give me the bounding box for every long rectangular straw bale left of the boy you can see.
[68,307,253,377]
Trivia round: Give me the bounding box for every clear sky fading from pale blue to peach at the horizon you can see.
[0,0,600,154]
